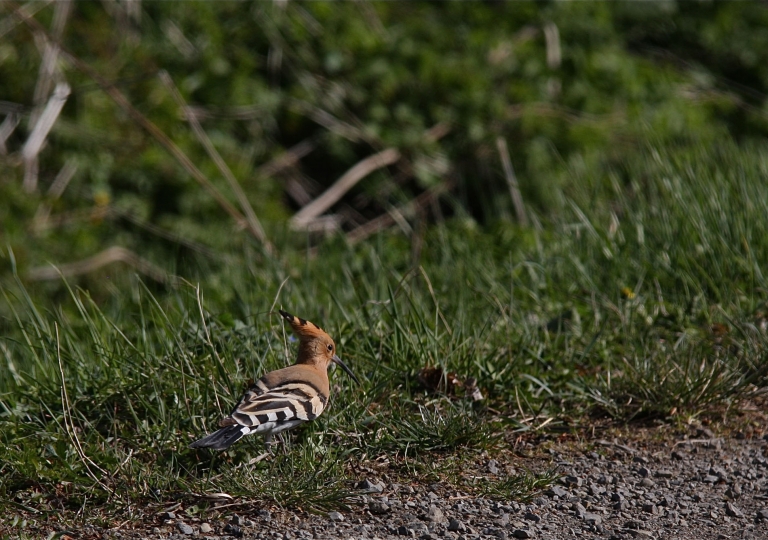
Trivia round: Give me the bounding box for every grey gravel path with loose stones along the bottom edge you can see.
[48,429,768,540]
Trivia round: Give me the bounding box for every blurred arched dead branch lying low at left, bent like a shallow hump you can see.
[27,246,176,284]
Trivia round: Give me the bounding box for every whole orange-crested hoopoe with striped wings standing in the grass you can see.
[189,310,360,451]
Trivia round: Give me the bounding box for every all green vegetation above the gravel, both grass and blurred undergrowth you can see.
[0,2,768,519]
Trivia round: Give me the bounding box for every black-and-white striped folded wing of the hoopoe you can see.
[230,379,328,434]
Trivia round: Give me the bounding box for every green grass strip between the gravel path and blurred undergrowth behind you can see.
[0,138,768,519]
